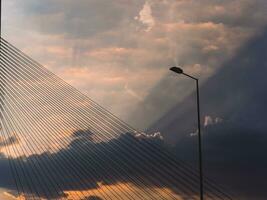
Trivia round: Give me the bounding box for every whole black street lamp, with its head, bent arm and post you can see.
[170,67,204,200]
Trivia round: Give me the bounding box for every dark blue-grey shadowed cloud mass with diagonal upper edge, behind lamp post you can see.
[151,29,267,199]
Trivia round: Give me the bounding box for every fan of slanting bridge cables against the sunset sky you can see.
[0,38,232,200]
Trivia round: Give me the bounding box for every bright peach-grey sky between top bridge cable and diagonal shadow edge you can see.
[2,0,267,129]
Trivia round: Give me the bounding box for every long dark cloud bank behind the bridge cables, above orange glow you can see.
[0,130,207,199]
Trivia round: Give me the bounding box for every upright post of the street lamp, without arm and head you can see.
[195,79,204,200]
